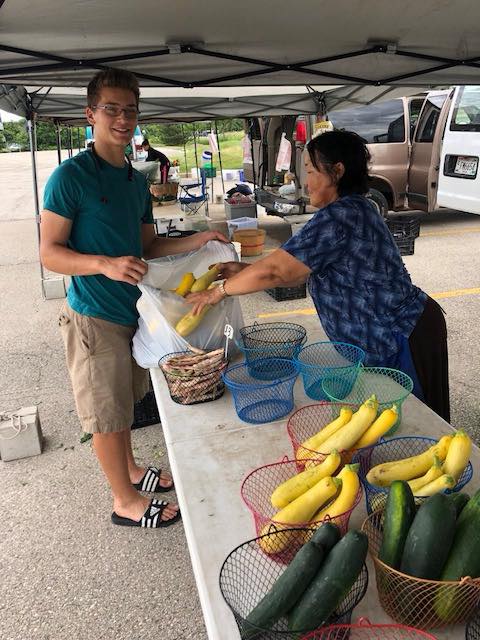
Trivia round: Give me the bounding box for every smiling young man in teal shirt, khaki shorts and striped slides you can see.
[40,69,227,527]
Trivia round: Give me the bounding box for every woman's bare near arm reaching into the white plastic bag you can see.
[186,249,311,315]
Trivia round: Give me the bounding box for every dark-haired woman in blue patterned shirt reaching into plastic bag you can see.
[187,131,450,421]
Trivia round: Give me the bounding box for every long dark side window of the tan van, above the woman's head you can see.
[329,100,405,143]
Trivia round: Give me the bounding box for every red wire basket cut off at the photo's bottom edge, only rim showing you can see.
[302,618,436,640]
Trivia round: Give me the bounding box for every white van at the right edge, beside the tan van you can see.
[437,86,480,214]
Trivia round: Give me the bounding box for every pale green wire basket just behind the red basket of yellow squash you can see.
[322,367,413,436]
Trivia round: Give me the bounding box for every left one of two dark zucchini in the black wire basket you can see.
[242,522,340,640]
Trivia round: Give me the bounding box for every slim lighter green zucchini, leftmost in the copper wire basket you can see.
[378,480,416,569]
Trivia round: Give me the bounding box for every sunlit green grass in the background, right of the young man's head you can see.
[150,131,244,173]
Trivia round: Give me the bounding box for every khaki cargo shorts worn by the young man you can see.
[58,302,149,433]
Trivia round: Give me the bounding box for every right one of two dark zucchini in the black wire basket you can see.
[288,530,368,633]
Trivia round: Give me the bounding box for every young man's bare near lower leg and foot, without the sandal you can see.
[93,429,178,520]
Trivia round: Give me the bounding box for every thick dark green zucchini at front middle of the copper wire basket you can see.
[400,493,457,580]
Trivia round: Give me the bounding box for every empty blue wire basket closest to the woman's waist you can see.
[296,341,365,400]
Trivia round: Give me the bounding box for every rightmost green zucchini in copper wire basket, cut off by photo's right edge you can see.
[434,494,480,622]
